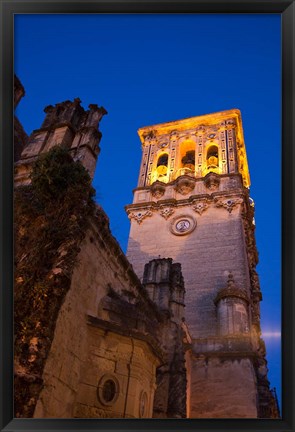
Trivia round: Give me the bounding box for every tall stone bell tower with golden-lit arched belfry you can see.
[126,109,278,418]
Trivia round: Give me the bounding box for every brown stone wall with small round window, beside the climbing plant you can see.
[34,213,164,418]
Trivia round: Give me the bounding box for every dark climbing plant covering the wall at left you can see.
[14,146,96,417]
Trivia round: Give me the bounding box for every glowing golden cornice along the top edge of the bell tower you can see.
[137,108,241,141]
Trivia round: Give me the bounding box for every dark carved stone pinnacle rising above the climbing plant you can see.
[15,96,107,185]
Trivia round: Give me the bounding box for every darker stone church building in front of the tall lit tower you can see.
[15,86,186,418]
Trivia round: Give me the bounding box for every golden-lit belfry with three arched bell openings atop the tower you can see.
[138,109,250,187]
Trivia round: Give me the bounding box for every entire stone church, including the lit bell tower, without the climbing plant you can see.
[15,80,279,418]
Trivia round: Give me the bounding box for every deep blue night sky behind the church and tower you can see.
[15,14,281,408]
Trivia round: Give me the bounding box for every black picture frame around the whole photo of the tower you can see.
[0,0,295,432]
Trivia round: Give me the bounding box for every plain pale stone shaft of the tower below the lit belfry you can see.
[127,179,250,337]
